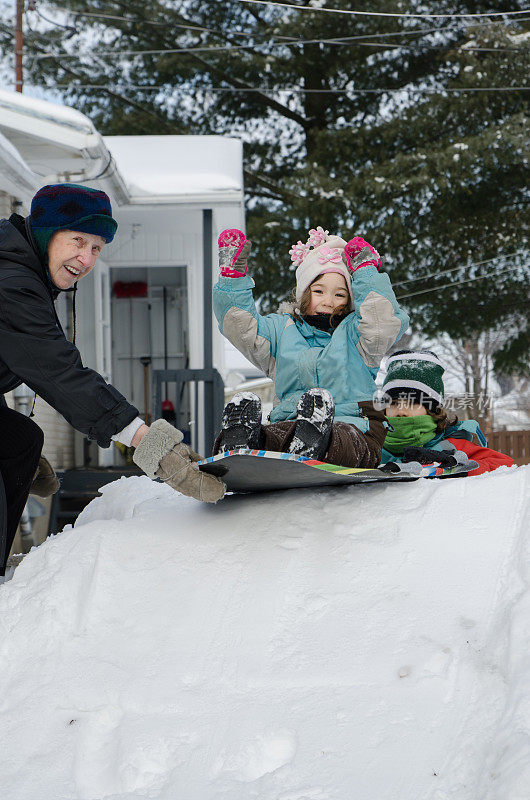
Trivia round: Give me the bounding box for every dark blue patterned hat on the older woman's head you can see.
[29,183,118,260]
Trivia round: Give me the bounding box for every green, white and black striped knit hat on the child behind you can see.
[383,350,445,411]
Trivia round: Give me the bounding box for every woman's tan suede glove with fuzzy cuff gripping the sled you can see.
[133,419,226,503]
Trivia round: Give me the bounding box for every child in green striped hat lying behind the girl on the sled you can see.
[382,350,514,475]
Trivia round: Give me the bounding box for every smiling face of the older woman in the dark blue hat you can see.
[48,231,105,289]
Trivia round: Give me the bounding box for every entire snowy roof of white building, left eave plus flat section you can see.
[0,89,243,205]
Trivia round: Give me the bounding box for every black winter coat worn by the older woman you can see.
[0,214,138,447]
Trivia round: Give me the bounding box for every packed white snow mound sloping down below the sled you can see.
[0,467,530,800]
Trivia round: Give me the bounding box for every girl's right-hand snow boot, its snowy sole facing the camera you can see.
[289,389,335,461]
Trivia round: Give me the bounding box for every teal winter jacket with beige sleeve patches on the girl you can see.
[213,266,409,431]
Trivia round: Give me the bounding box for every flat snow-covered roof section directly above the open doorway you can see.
[104,136,243,202]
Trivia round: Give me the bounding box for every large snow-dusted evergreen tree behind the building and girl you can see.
[2,0,530,371]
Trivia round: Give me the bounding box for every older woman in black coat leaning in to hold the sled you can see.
[0,183,224,576]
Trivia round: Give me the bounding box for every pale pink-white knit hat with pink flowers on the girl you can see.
[289,225,353,303]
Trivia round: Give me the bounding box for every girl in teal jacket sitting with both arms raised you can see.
[213,227,408,467]
